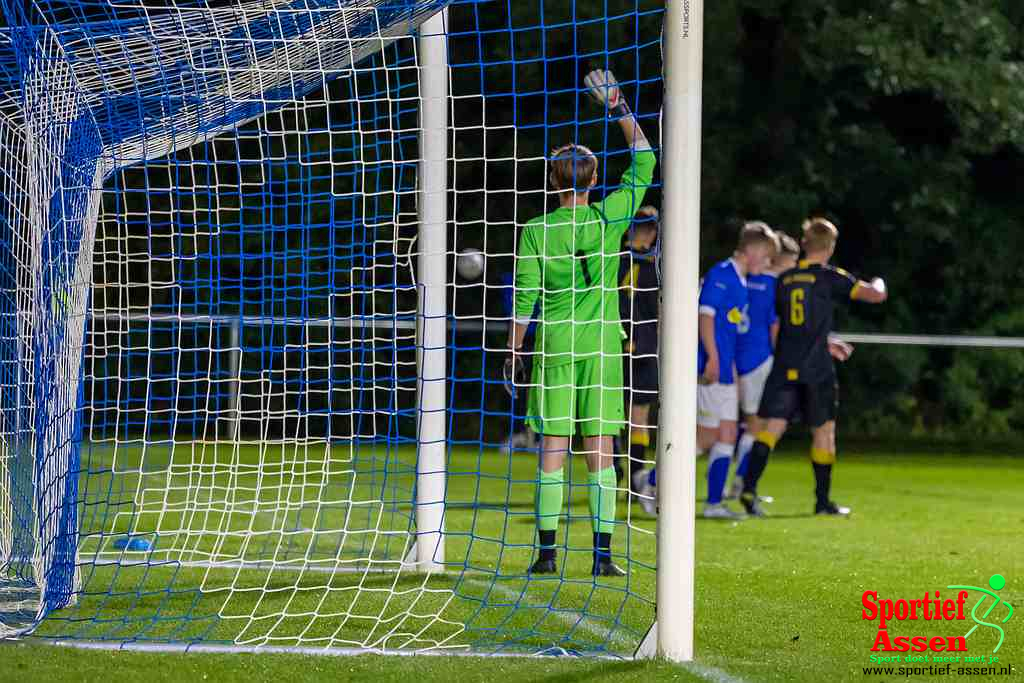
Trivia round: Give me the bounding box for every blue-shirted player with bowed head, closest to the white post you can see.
[697,223,776,519]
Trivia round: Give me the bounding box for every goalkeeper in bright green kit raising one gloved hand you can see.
[506,71,656,577]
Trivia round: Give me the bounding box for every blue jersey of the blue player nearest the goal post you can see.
[697,258,748,384]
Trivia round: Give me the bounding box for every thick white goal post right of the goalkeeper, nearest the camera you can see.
[656,0,703,661]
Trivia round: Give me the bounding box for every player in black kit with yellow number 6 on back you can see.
[739,218,889,516]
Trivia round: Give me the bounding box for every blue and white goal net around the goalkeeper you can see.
[0,0,662,655]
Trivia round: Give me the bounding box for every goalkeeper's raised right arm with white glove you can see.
[584,71,657,233]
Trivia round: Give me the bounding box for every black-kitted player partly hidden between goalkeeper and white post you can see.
[615,206,659,514]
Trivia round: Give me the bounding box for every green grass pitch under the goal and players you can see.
[0,439,1024,681]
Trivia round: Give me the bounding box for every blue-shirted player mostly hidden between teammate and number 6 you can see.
[729,223,800,499]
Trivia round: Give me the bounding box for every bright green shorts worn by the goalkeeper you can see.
[526,355,626,436]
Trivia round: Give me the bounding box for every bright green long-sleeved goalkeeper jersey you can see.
[515,148,656,367]
